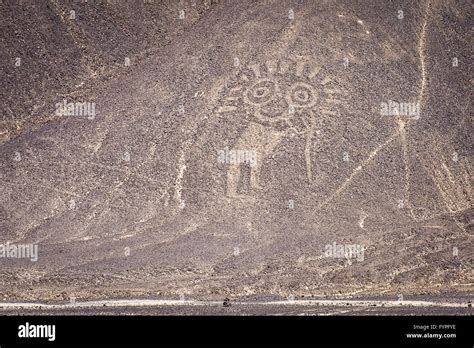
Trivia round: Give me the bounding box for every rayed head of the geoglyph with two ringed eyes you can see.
[218,58,345,133]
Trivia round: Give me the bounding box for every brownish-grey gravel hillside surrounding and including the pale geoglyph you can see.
[0,0,473,314]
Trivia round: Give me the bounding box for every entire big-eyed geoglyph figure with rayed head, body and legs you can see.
[218,58,347,197]
